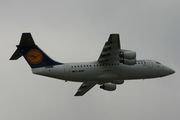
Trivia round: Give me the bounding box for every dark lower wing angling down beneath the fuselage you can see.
[74,82,96,96]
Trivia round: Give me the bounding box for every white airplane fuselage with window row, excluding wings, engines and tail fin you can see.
[32,60,170,84]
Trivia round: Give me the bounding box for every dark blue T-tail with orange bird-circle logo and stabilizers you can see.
[10,33,62,68]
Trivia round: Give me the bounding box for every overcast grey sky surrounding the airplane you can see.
[0,0,180,120]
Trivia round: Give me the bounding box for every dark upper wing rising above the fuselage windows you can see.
[98,34,121,62]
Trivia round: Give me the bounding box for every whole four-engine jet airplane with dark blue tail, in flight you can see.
[10,33,175,96]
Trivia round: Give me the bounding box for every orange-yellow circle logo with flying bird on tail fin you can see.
[27,49,43,64]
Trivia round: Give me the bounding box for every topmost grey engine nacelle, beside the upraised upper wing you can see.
[119,50,136,60]
